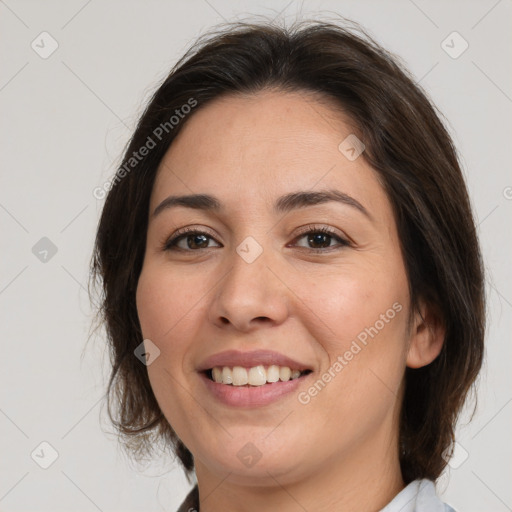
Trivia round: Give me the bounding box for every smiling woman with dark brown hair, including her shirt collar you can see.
[93,19,484,512]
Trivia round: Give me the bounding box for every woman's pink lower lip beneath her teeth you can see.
[200,373,311,407]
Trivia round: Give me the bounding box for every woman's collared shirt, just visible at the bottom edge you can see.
[177,478,456,512]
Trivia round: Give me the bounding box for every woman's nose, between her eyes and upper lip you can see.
[209,245,290,332]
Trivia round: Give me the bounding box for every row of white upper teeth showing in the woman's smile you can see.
[212,365,303,386]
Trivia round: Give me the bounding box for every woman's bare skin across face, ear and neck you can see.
[137,91,444,512]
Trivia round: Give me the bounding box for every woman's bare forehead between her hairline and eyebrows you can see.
[151,91,389,220]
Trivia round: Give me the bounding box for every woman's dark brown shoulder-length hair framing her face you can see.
[92,22,485,483]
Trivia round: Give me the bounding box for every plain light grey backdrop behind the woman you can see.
[0,0,512,512]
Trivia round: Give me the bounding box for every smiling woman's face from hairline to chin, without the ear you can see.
[137,91,422,484]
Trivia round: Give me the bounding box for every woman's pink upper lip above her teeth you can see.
[198,350,311,372]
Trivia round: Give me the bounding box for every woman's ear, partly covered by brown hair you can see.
[407,302,446,368]
